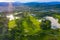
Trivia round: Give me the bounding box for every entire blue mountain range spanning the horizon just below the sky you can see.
[0,2,60,6]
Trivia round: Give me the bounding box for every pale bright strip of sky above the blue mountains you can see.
[0,0,60,2]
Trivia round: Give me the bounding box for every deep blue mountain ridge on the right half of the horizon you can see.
[24,2,60,7]
